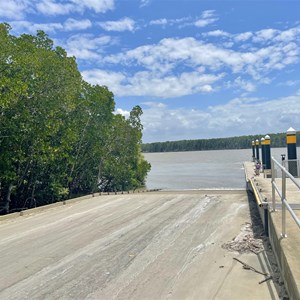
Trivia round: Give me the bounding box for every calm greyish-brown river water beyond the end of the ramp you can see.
[144,148,299,190]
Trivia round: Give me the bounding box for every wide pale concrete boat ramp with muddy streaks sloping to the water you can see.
[0,190,290,300]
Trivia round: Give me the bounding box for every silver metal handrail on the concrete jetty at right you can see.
[271,157,300,237]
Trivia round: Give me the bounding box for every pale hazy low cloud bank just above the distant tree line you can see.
[142,92,300,142]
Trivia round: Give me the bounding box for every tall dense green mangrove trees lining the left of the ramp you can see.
[0,24,150,213]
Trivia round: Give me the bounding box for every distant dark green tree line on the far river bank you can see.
[142,132,300,152]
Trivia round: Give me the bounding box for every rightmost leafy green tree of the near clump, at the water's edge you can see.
[99,106,150,191]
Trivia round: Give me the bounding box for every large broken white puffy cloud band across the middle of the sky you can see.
[81,32,300,98]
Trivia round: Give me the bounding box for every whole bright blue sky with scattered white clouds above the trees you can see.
[0,0,300,142]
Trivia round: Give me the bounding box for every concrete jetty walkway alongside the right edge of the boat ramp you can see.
[244,158,300,299]
